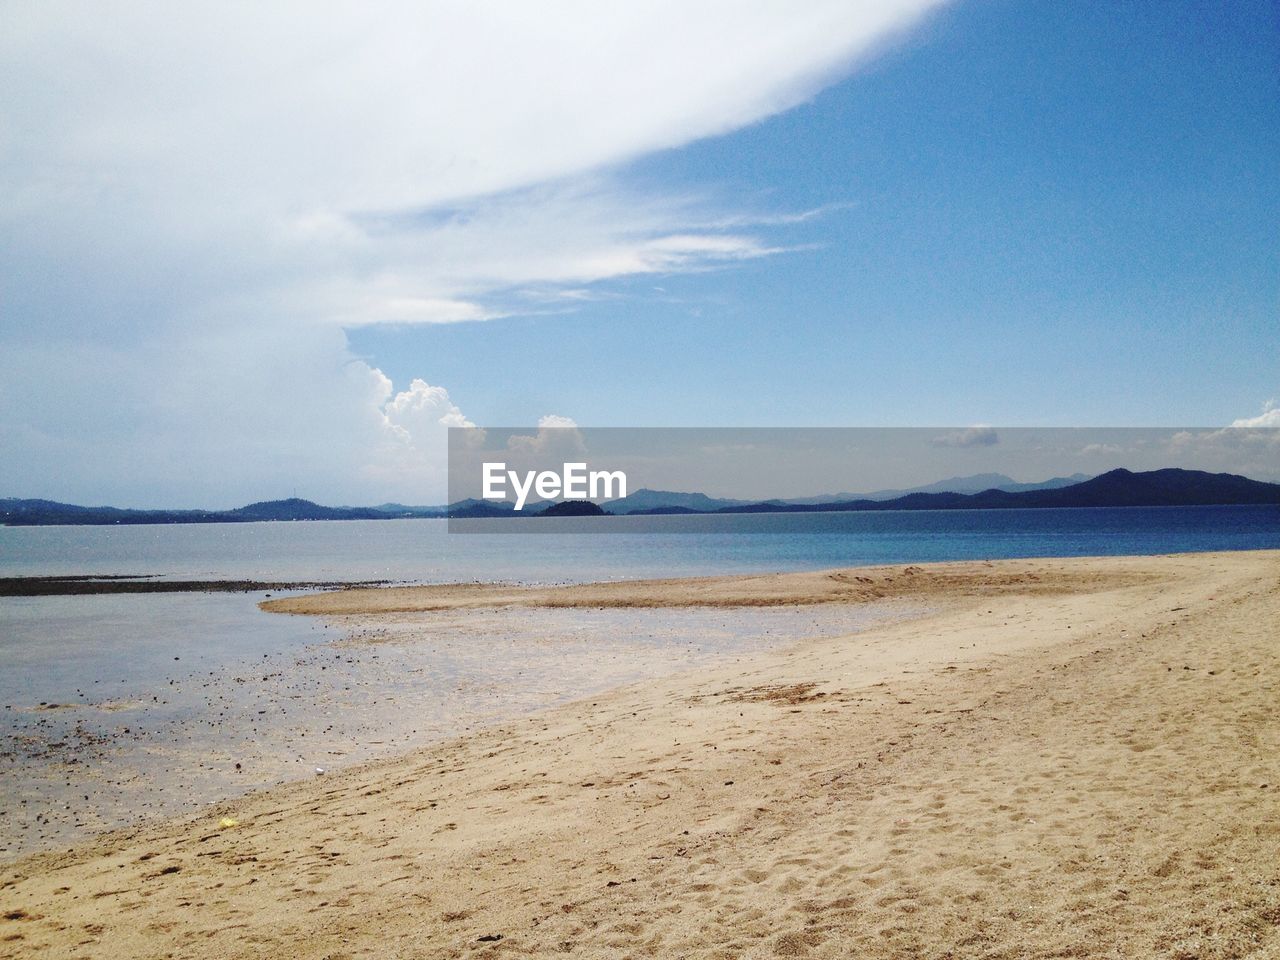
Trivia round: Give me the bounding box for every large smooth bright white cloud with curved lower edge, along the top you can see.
[0,0,936,220]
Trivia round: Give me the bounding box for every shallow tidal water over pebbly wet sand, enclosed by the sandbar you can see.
[0,596,916,859]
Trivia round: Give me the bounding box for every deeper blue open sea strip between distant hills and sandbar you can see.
[0,507,1280,582]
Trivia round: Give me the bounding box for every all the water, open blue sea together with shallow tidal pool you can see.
[0,506,1280,859]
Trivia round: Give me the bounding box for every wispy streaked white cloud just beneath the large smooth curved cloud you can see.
[316,174,817,326]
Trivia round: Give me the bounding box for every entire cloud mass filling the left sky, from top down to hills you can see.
[0,0,938,506]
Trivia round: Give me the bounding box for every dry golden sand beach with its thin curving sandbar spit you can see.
[0,552,1280,960]
